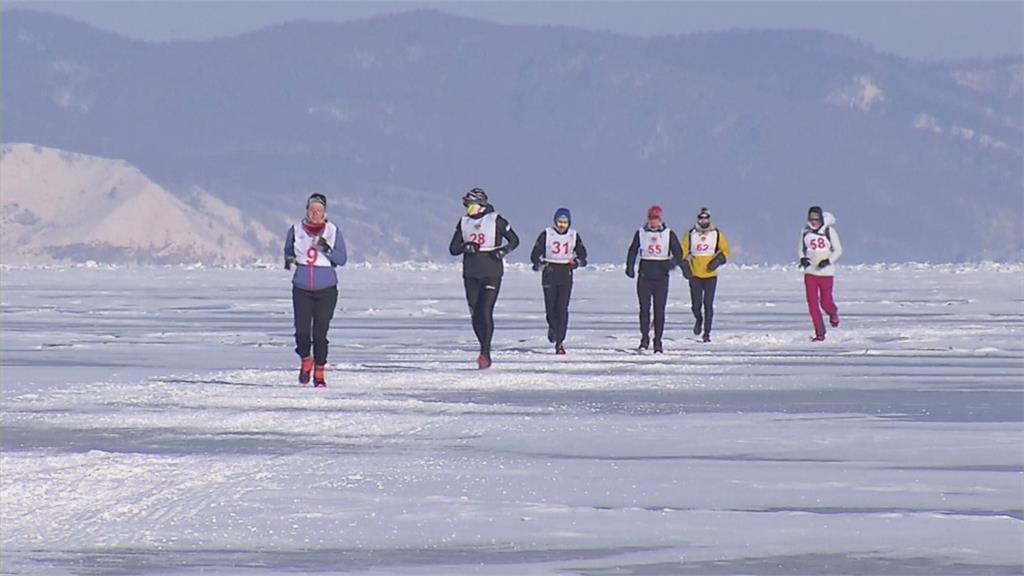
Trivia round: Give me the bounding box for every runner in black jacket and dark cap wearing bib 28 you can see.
[449,188,519,370]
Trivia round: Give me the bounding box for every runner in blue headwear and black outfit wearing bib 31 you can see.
[529,208,587,355]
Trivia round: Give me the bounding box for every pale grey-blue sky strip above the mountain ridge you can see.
[4,0,1024,59]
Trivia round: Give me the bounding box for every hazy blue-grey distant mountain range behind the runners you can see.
[0,10,1024,262]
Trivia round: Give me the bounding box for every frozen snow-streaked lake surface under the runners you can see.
[0,265,1024,576]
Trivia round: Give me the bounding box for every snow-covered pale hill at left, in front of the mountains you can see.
[0,143,276,264]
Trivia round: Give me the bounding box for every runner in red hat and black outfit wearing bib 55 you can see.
[626,206,683,354]
